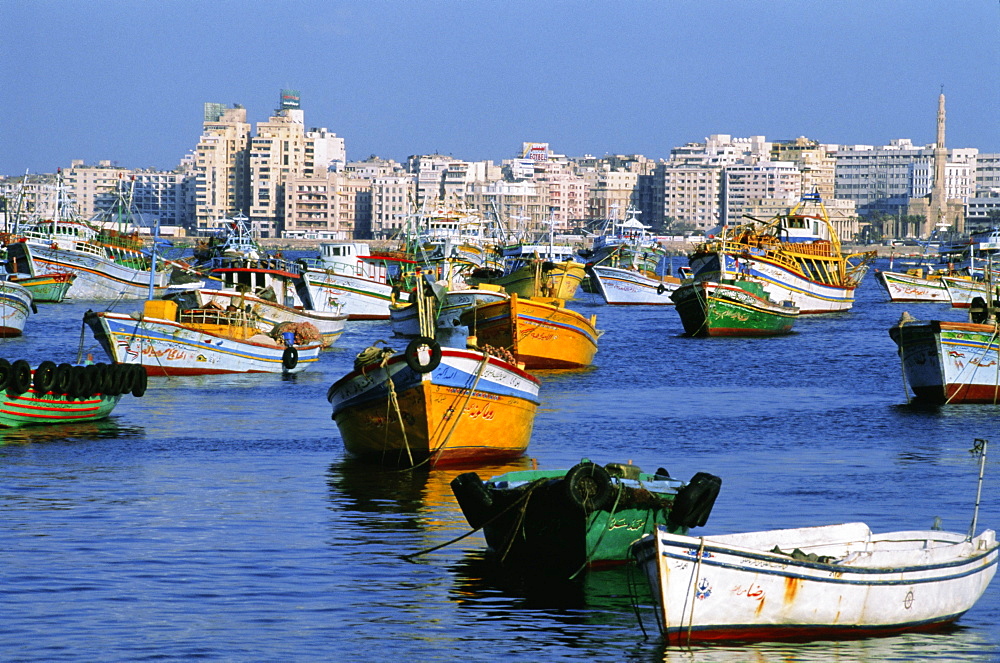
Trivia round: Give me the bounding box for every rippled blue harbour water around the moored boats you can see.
[0,260,1000,662]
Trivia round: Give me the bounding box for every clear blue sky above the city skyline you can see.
[0,0,1000,175]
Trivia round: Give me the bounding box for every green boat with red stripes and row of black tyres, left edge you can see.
[0,359,146,428]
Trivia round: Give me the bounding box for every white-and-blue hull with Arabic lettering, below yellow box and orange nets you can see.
[84,311,320,376]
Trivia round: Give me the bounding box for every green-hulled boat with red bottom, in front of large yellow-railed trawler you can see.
[671,279,799,336]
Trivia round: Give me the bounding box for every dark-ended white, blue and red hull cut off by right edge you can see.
[889,320,1000,403]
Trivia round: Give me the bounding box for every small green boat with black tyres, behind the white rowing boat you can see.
[451,458,722,578]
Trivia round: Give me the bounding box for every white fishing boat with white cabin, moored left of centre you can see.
[298,242,416,320]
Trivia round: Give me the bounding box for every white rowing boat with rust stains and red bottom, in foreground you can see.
[633,523,997,645]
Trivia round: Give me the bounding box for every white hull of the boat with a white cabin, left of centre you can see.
[302,269,392,320]
